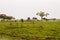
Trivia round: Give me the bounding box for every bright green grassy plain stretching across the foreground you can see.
[0,21,60,40]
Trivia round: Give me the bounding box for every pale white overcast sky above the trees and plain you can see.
[0,0,60,19]
